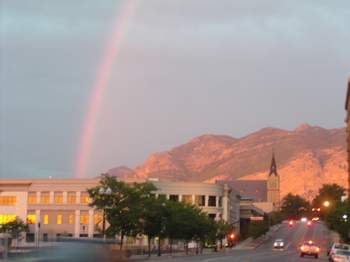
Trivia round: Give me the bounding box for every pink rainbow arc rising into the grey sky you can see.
[74,0,135,178]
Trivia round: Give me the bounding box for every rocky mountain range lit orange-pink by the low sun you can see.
[110,124,347,200]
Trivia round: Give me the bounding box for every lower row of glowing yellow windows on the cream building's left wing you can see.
[27,213,102,225]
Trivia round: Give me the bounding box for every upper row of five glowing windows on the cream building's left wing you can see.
[28,192,90,205]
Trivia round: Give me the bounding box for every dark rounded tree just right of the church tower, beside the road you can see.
[281,193,310,219]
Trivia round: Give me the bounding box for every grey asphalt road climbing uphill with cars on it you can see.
[148,222,331,262]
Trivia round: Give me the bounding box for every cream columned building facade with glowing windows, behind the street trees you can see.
[0,179,239,241]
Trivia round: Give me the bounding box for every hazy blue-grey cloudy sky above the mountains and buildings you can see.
[0,0,350,178]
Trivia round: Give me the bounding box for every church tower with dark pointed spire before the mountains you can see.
[267,153,280,209]
